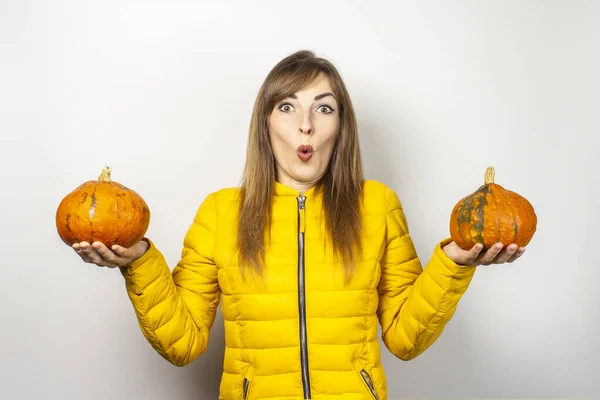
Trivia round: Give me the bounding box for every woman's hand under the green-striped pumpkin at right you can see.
[443,242,525,266]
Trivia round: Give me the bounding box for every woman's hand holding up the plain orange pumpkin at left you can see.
[72,240,149,268]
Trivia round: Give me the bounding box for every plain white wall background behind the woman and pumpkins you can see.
[0,0,600,400]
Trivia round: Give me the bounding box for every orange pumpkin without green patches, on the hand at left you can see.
[56,167,150,248]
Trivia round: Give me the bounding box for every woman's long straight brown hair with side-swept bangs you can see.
[237,50,364,279]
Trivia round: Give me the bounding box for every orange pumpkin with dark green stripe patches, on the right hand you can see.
[450,167,537,250]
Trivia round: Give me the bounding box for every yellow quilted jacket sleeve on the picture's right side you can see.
[377,189,476,360]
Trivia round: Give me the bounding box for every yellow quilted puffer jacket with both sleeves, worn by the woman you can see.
[122,181,475,400]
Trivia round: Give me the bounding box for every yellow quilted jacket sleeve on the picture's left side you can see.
[121,194,220,366]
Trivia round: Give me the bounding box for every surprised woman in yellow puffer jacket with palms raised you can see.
[73,51,524,399]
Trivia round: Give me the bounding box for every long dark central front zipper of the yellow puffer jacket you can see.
[298,196,311,399]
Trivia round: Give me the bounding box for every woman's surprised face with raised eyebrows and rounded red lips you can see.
[269,75,340,192]
